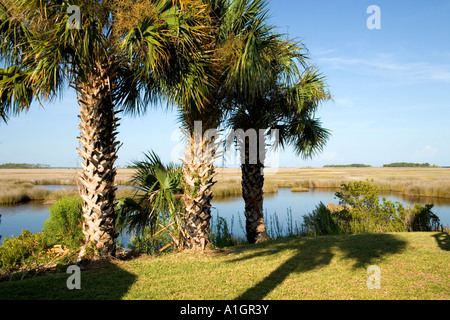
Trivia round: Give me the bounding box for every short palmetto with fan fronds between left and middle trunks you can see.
[117,152,185,249]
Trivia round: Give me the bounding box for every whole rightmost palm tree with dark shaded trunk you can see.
[228,36,330,243]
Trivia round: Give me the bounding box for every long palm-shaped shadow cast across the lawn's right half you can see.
[231,234,406,300]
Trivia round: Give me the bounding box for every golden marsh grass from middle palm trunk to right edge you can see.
[213,168,450,199]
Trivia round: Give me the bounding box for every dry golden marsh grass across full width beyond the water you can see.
[0,168,450,204]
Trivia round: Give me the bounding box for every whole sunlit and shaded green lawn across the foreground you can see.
[0,233,450,300]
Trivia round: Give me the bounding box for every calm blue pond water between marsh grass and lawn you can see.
[0,186,450,244]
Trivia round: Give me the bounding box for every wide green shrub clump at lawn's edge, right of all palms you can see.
[303,181,442,235]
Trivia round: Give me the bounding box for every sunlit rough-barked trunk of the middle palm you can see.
[183,126,217,252]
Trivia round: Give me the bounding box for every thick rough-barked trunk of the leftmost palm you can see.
[76,66,119,258]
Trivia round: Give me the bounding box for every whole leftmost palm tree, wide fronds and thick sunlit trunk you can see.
[0,0,209,257]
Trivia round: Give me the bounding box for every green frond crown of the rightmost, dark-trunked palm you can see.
[227,23,331,158]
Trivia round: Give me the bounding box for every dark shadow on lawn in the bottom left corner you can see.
[0,262,136,300]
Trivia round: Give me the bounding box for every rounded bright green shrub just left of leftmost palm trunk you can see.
[43,196,84,250]
